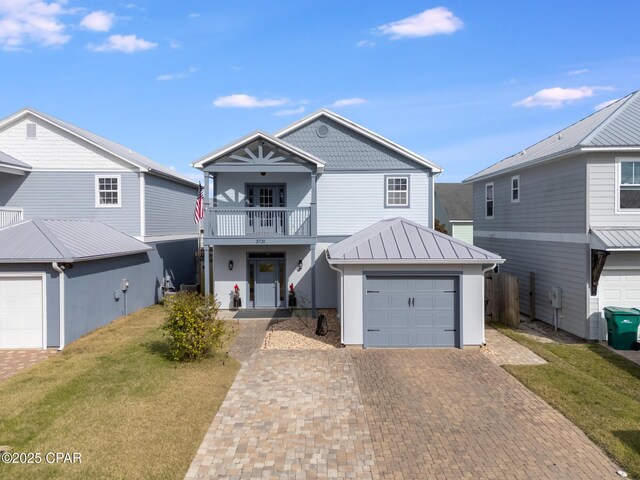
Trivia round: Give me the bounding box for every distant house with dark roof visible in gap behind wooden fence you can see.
[434,183,473,244]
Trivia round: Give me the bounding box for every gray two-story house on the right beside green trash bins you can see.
[465,88,640,340]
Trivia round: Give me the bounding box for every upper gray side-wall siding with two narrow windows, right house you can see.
[473,156,587,233]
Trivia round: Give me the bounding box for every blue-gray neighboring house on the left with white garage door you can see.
[0,109,197,348]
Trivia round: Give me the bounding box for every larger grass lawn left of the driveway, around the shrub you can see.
[0,306,239,479]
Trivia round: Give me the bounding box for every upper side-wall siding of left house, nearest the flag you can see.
[145,174,198,235]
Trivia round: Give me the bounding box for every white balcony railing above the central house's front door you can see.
[207,207,311,238]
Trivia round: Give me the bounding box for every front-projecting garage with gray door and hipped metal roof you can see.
[326,218,504,348]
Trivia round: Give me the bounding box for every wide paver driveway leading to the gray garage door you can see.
[186,324,617,479]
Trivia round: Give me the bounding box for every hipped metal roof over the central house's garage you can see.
[327,217,504,264]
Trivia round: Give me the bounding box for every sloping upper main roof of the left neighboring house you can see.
[18,108,197,186]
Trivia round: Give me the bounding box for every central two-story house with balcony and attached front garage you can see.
[193,110,501,346]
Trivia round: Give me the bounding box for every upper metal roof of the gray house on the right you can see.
[464,90,640,183]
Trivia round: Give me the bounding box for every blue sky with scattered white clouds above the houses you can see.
[0,0,640,181]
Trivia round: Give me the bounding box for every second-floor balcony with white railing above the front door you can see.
[204,207,315,244]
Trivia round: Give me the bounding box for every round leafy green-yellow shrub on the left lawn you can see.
[162,292,226,362]
